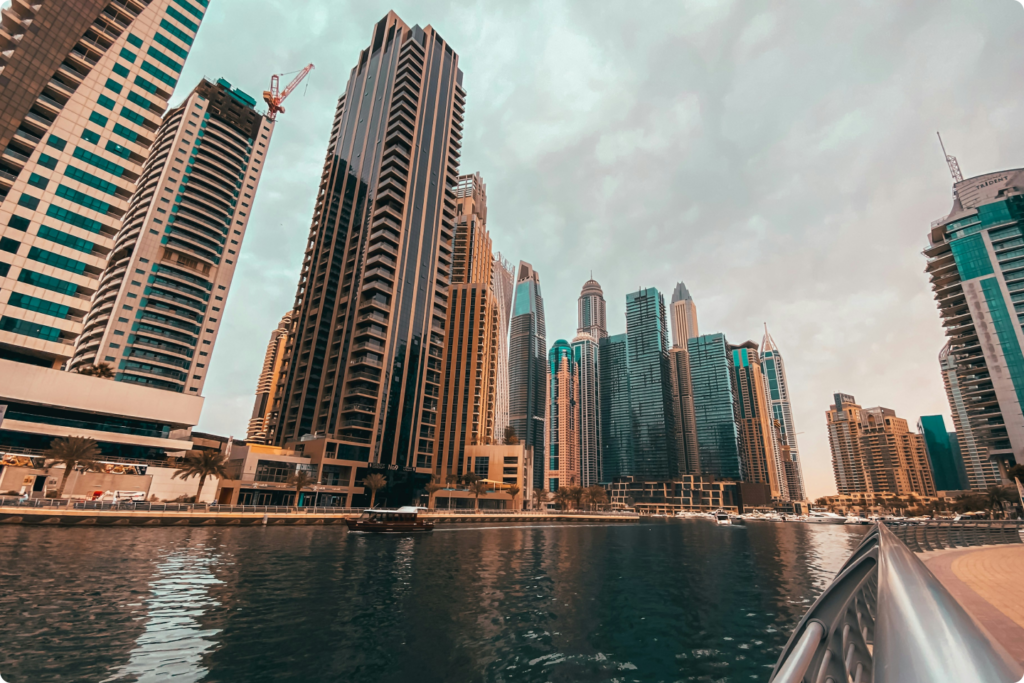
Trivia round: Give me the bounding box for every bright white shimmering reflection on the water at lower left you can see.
[104,543,222,683]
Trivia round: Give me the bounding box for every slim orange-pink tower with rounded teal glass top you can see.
[544,339,583,492]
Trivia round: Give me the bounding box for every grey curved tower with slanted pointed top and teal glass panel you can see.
[509,261,548,488]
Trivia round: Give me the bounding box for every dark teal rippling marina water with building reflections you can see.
[0,519,865,683]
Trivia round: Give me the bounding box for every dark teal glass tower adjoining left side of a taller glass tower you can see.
[598,335,635,483]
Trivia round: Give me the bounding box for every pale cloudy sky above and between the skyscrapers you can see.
[176,0,1024,498]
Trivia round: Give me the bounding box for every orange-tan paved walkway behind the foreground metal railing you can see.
[918,545,1024,665]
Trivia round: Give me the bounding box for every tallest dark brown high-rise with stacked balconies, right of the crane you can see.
[271,12,466,489]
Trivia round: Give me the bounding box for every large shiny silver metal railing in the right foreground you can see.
[769,524,1024,683]
